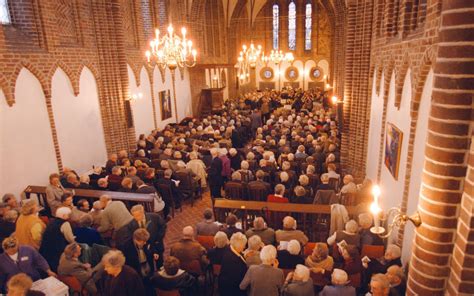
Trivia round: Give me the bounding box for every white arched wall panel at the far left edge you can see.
[0,69,57,196]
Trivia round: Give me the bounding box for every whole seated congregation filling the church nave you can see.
[0,88,406,296]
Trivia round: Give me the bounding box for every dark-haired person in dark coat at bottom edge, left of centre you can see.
[151,256,198,296]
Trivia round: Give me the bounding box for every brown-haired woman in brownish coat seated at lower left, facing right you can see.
[58,243,101,295]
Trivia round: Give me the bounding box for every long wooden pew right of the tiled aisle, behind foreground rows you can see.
[214,198,356,241]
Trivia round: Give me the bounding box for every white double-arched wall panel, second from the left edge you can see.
[51,68,107,174]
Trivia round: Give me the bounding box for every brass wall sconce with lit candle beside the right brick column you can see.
[370,185,422,238]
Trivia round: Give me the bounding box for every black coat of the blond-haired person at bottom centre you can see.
[218,247,247,296]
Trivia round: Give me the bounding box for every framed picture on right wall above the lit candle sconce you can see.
[384,123,403,180]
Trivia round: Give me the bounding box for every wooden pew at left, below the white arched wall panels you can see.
[24,185,154,212]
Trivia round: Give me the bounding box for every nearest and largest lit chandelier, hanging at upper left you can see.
[145,25,197,70]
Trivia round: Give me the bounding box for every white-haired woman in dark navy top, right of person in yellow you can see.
[39,207,75,270]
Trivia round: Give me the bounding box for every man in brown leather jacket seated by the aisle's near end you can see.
[170,226,209,269]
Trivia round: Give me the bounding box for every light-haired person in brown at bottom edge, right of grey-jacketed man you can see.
[282,264,314,296]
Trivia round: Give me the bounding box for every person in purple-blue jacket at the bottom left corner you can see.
[0,236,56,284]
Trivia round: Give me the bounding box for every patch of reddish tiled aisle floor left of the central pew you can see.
[164,191,211,255]
